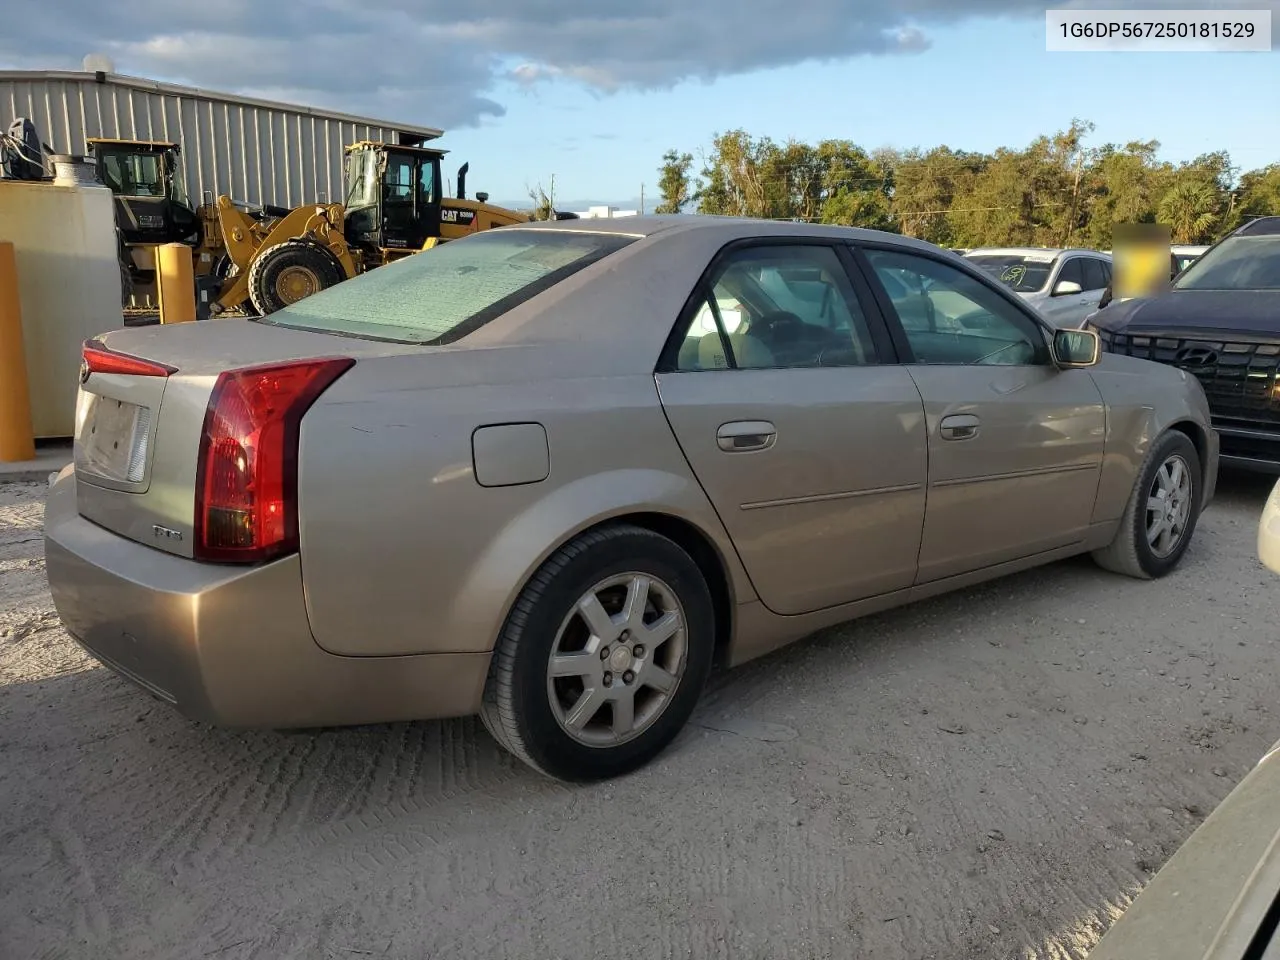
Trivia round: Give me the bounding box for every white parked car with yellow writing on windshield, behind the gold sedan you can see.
[965,247,1111,328]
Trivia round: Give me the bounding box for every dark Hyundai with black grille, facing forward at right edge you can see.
[1085,216,1280,472]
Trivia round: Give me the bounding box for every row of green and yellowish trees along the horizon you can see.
[657,120,1280,250]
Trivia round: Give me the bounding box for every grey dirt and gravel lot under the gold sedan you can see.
[0,477,1280,960]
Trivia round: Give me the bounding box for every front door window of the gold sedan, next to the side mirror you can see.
[867,250,1048,365]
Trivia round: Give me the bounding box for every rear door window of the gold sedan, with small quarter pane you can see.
[676,244,877,371]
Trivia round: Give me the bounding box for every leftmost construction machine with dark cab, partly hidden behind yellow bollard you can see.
[87,137,204,306]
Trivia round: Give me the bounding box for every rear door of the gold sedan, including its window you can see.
[658,242,927,614]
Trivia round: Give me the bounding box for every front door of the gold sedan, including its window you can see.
[864,248,1106,582]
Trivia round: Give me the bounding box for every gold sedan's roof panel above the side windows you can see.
[502,214,962,252]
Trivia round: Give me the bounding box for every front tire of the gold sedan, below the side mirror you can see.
[1093,430,1204,580]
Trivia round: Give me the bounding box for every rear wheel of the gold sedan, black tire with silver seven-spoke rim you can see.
[480,525,716,782]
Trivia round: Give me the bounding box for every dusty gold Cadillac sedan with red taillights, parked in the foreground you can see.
[45,216,1217,778]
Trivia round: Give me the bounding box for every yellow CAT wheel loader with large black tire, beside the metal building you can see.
[200,141,530,315]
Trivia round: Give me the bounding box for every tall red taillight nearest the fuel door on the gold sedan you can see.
[195,357,356,563]
